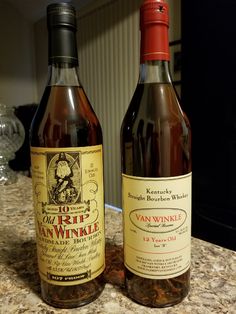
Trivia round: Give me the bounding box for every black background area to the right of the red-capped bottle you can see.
[181,0,236,250]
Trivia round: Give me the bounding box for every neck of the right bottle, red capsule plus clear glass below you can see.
[139,0,171,83]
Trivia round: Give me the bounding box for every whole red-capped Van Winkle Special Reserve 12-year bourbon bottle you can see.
[121,0,191,307]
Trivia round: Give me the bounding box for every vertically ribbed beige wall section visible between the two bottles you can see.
[78,0,141,206]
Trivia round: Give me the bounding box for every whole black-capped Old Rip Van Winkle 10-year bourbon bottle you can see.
[30,3,105,308]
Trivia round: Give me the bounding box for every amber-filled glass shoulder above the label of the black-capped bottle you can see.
[31,86,102,147]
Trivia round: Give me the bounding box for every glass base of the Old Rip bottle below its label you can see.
[41,275,105,309]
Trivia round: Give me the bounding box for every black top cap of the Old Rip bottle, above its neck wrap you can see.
[47,3,76,29]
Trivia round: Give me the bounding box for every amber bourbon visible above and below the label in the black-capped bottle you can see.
[31,86,104,308]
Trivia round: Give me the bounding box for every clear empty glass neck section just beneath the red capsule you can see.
[139,60,171,84]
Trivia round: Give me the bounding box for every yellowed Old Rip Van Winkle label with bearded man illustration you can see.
[31,145,105,286]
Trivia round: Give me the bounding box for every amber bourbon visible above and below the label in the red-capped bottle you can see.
[121,83,191,307]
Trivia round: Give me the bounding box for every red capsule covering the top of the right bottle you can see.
[140,0,170,62]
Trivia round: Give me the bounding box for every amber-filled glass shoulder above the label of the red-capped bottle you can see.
[121,83,191,177]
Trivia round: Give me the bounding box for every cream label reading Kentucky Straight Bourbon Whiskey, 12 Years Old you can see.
[122,173,191,279]
